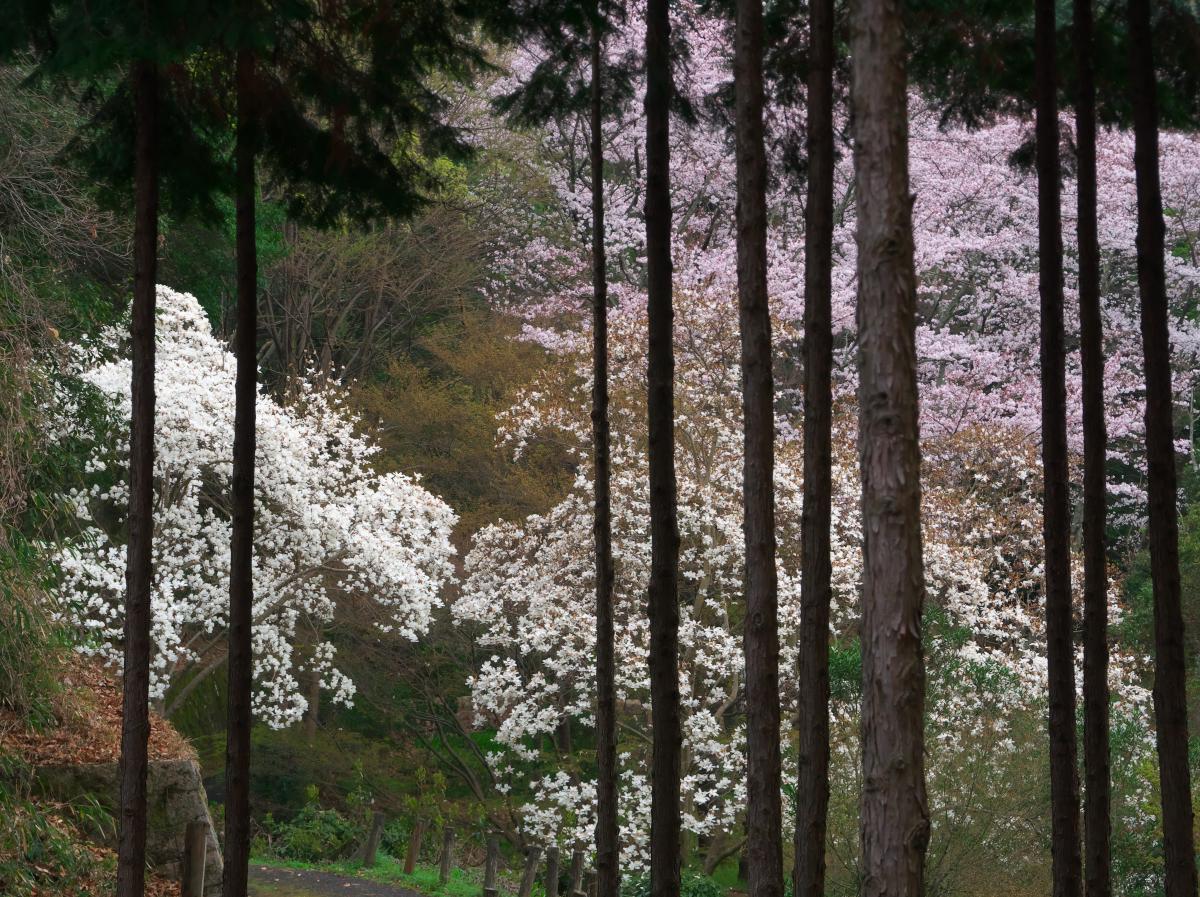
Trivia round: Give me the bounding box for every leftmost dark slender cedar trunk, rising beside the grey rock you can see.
[116,54,158,897]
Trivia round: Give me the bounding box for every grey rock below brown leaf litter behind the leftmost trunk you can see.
[34,759,222,897]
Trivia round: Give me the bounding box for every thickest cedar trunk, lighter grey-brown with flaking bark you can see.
[851,0,929,897]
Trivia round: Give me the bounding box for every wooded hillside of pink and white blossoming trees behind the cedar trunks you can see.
[0,0,1200,897]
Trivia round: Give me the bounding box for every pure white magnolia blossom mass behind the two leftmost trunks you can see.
[52,287,455,727]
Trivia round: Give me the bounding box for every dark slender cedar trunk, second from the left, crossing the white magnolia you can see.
[223,43,258,897]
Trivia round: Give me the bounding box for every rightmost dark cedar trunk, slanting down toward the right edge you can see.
[1129,0,1196,897]
